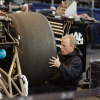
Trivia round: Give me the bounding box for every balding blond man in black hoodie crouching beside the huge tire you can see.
[29,35,82,94]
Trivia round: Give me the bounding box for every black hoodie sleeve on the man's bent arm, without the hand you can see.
[58,57,82,80]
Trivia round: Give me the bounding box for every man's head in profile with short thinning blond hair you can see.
[60,35,77,55]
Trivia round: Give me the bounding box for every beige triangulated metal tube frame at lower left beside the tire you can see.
[0,47,25,98]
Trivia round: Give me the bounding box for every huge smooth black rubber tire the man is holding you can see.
[8,12,56,86]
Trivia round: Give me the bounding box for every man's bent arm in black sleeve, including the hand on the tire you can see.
[49,57,82,80]
